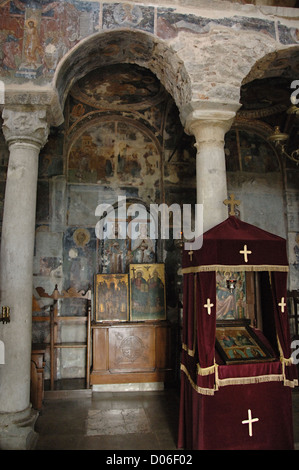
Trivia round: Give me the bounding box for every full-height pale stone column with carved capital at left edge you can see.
[0,109,48,449]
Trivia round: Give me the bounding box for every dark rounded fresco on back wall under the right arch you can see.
[225,130,280,173]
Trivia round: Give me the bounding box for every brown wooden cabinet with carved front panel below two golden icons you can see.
[90,321,173,385]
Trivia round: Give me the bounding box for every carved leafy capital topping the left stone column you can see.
[2,108,49,148]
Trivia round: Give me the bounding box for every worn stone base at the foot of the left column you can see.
[0,407,39,450]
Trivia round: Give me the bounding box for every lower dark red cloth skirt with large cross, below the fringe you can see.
[178,377,294,450]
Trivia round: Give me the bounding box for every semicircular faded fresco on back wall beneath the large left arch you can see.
[68,120,160,187]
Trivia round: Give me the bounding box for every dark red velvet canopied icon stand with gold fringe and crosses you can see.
[178,217,297,449]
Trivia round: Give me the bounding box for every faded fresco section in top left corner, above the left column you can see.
[0,0,99,82]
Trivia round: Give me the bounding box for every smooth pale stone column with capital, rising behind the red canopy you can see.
[185,109,235,232]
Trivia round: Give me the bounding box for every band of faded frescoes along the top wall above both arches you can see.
[0,0,298,84]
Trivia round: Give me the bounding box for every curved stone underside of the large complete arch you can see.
[53,29,191,115]
